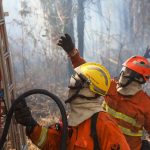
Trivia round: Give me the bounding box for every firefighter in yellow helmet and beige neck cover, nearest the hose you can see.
[15,63,130,150]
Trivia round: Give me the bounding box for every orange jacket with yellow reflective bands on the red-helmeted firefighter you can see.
[70,49,150,150]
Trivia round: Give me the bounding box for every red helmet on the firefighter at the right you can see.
[122,56,150,81]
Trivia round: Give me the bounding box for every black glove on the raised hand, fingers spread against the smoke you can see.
[57,34,75,54]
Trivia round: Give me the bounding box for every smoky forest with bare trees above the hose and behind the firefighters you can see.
[3,0,150,98]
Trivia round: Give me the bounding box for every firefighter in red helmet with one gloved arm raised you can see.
[58,34,150,150]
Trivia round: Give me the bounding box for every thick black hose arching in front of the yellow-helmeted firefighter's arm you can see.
[0,89,68,150]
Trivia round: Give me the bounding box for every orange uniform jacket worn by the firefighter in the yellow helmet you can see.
[28,112,130,150]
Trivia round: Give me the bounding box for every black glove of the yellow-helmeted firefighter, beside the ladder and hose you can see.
[14,100,37,128]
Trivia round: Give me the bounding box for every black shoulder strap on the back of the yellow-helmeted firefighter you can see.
[91,112,100,150]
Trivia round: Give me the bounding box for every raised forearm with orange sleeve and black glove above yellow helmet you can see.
[57,34,86,68]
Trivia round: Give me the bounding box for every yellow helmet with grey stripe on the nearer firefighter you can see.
[74,62,110,96]
